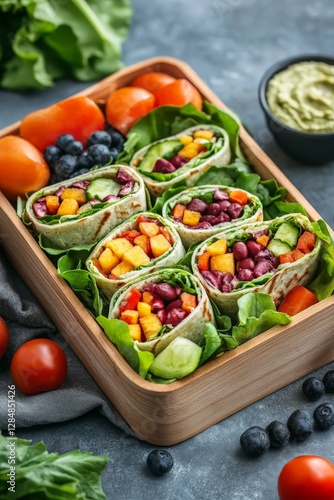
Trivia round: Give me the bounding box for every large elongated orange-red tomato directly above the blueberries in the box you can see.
[20,96,105,152]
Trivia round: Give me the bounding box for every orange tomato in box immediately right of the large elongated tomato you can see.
[106,87,155,135]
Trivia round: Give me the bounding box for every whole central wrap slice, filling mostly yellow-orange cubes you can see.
[86,212,185,300]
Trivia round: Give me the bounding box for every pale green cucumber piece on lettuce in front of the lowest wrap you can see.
[149,337,202,379]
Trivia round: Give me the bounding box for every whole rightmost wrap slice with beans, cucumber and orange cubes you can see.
[191,214,322,317]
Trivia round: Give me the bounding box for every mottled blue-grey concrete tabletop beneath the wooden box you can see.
[0,0,334,500]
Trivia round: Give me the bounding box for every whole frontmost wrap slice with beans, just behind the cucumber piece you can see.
[108,268,215,356]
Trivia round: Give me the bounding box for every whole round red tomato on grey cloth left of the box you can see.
[10,339,67,394]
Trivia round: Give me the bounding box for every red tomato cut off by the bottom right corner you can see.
[278,455,334,500]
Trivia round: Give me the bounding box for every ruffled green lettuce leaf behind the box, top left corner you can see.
[0,0,132,90]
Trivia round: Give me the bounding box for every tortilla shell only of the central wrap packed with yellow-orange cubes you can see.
[86,212,185,300]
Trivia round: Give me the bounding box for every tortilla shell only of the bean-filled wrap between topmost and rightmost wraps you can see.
[162,185,263,248]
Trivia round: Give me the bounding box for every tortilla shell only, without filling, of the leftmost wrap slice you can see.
[26,165,147,249]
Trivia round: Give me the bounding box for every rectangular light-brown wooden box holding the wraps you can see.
[0,57,334,446]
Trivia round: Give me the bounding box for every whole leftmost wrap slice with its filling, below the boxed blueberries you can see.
[26,165,147,249]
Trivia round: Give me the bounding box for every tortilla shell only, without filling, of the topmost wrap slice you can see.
[130,125,231,197]
